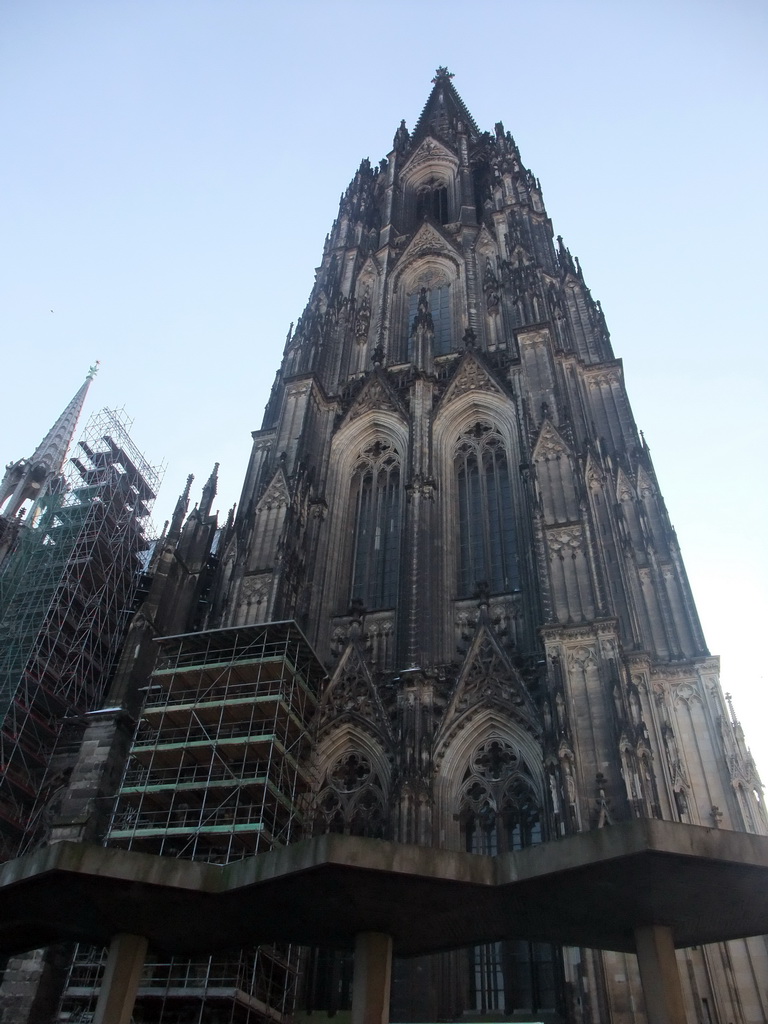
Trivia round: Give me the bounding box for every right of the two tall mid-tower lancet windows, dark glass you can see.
[455,423,519,597]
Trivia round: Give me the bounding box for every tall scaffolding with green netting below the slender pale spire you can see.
[0,410,159,860]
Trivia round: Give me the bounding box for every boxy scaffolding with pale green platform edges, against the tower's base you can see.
[59,622,325,1024]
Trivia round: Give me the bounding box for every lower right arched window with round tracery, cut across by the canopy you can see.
[459,738,561,1014]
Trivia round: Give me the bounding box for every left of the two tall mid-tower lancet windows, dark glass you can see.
[351,441,402,610]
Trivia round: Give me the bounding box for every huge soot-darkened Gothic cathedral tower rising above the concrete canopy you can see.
[209,68,768,1024]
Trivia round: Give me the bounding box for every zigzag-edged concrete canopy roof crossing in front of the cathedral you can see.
[0,819,768,955]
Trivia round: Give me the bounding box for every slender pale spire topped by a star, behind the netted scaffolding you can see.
[0,361,98,516]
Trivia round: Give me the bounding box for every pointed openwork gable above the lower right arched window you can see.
[435,624,541,749]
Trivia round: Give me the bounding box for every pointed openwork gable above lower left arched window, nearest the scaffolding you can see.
[316,640,392,749]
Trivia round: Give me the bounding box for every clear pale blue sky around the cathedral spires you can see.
[0,0,768,781]
